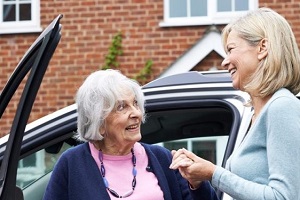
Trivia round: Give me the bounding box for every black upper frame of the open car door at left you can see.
[0,15,62,200]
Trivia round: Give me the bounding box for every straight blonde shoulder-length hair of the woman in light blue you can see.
[222,8,300,97]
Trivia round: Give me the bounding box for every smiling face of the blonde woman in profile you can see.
[222,30,259,90]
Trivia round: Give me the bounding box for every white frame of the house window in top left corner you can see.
[0,0,42,34]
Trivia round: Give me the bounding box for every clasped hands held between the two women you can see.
[170,148,216,188]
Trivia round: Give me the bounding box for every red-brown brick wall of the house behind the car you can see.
[0,0,300,136]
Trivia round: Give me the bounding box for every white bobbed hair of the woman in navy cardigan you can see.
[75,69,145,141]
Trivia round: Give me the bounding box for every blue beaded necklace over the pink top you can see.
[98,148,137,198]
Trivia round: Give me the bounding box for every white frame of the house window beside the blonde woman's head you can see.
[159,0,258,27]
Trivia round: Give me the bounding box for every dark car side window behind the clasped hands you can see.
[142,98,240,166]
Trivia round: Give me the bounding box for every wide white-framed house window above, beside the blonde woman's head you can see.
[160,0,258,27]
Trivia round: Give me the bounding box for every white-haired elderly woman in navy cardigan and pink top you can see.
[44,70,217,200]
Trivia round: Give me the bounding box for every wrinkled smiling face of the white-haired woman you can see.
[100,90,142,146]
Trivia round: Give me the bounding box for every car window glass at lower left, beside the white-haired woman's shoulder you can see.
[17,143,71,188]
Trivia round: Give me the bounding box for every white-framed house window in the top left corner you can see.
[0,0,42,34]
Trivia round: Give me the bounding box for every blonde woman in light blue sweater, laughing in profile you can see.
[170,8,300,200]
